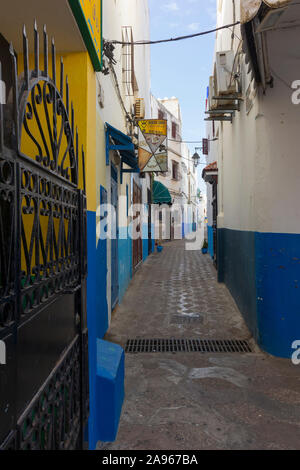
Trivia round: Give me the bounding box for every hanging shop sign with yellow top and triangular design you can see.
[138,119,168,173]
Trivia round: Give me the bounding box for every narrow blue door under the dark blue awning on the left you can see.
[111,167,119,310]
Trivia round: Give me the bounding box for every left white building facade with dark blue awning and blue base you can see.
[96,0,153,327]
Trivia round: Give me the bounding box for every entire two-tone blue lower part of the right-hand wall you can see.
[218,229,300,358]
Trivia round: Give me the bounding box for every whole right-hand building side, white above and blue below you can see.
[203,0,300,357]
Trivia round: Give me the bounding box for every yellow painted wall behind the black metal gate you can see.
[18,52,96,274]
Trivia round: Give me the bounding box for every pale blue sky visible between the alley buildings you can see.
[149,0,216,187]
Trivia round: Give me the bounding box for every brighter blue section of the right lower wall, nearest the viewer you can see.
[255,233,300,357]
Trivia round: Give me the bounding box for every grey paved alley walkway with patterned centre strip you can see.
[106,241,300,450]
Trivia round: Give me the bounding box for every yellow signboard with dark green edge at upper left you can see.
[69,0,103,72]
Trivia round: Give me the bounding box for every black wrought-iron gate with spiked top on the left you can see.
[0,25,89,450]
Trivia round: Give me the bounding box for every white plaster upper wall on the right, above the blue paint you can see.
[208,0,300,233]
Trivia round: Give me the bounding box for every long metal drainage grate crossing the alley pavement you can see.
[125,338,252,353]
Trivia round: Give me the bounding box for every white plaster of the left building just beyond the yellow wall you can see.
[97,0,151,316]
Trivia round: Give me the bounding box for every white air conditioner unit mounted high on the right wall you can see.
[216,51,236,96]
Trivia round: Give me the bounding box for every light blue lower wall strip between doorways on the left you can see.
[118,227,132,303]
